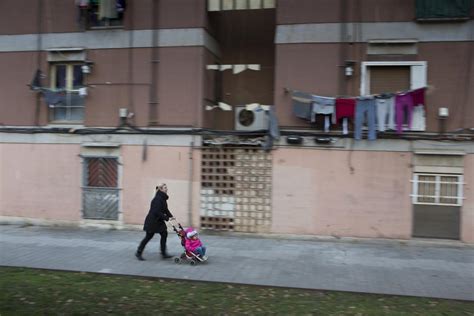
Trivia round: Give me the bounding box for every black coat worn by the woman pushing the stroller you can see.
[143,191,173,233]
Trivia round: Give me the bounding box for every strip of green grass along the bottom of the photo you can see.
[0,267,474,316]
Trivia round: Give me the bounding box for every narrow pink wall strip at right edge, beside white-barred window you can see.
[461,155,474,243]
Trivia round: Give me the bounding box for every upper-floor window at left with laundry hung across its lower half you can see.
[48,63,84,122]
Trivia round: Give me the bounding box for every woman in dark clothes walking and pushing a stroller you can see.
[135,183,173,261]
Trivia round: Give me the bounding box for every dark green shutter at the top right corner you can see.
[416,0,473,20]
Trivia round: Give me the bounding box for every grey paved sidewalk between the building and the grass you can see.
[0,225,474,301]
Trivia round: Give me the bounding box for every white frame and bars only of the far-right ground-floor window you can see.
[410,173,464,206]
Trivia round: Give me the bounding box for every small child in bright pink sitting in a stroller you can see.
[173,223,207,265]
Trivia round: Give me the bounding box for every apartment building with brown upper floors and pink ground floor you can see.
[0,0,474,243]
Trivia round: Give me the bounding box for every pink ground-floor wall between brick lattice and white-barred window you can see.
[272,148,412,238]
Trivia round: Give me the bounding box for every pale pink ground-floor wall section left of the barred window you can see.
[0,144,82,220]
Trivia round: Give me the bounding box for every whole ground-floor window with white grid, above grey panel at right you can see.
[412,173,463,206]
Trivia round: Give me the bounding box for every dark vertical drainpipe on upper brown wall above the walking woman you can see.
[148,0,160,125]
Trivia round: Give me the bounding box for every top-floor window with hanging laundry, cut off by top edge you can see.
[76,0,126,28]
